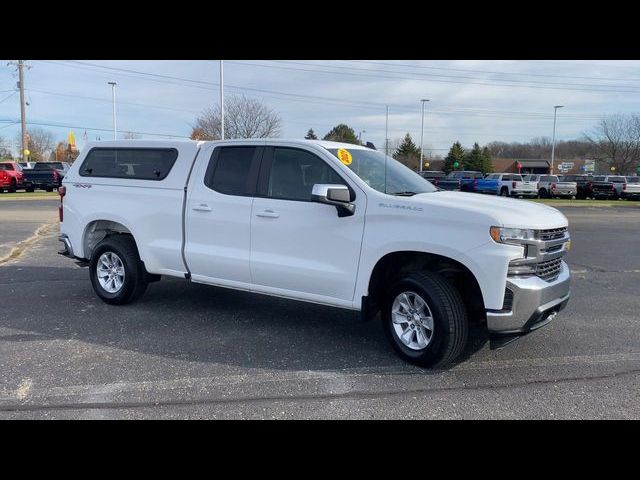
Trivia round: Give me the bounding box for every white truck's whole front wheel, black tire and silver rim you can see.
[382,271,468,367]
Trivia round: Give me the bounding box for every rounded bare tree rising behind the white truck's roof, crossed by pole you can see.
[191,95,282,140]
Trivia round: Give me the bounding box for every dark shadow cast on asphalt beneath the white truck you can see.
[0,266,487,373]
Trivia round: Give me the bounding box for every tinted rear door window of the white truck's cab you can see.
[204,147,262,195]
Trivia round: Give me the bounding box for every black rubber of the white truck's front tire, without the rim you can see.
[382,271,469,368]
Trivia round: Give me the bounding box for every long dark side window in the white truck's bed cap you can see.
[81,148,178,180]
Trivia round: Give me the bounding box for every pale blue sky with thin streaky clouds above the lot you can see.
[0,60,640,155]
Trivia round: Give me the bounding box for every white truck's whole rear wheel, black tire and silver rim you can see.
[89,235,148,305]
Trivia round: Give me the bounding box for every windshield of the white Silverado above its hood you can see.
[327,148,437,195]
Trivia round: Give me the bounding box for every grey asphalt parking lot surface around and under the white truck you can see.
[0,200,640,419]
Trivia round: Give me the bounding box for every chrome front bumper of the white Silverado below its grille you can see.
[487,261,571,334]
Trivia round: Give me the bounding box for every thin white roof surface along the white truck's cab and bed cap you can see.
[80,138,369,150]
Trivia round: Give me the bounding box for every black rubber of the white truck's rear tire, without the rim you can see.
[89,235,148,305]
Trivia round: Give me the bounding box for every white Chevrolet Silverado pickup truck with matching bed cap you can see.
[59,139,570,366]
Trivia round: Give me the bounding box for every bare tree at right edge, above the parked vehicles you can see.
[585,114,640,175]
